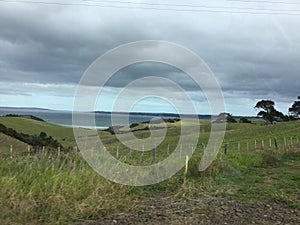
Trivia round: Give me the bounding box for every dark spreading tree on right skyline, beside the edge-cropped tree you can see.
[254,100,286,124]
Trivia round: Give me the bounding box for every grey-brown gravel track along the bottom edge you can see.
[76,196,300,225]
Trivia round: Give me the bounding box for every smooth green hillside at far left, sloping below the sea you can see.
[0,117,75,147]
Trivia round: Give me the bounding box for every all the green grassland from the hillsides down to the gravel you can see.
[0,117,300,224]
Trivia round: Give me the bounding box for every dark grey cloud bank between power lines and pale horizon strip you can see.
[0,0,300,106]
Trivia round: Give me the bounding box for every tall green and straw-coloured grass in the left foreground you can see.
[0,154,133,224]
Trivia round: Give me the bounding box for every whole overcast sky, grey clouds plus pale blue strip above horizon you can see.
[0,0,300,115]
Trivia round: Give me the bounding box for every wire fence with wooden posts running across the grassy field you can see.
[0,136,300,159]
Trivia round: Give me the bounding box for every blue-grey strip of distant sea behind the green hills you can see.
[0,107,180,129]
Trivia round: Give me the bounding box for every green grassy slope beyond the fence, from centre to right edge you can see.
[99,120,300,163]
